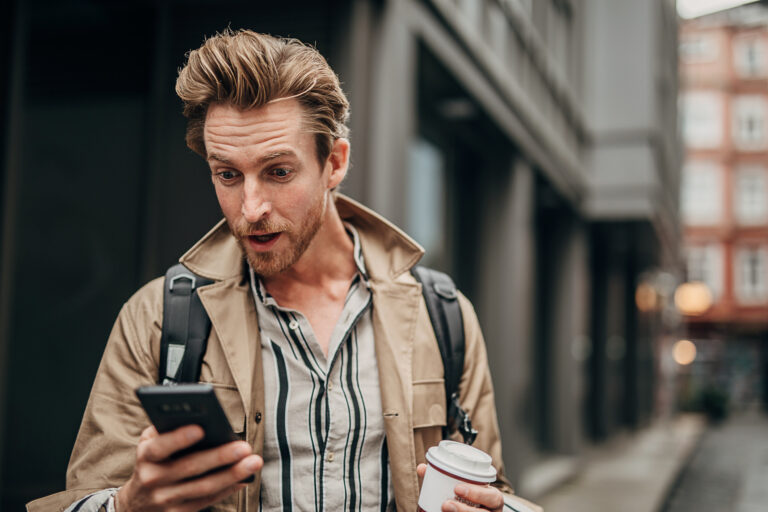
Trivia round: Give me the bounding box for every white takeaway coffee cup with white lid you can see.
[419,441,496,512]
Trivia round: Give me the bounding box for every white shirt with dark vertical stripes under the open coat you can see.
[251,225,394,512]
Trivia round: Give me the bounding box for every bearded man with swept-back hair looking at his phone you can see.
[28,30,533,512]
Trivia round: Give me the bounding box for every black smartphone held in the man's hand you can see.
[136,384,253,482]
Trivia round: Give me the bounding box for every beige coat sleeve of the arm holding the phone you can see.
[27,278,163,512]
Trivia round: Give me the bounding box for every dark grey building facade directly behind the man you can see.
[0,0,681,509]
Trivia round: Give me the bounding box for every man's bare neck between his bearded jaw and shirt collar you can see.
[262,198,356,296]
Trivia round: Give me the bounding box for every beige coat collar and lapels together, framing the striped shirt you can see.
[179,195,424,510]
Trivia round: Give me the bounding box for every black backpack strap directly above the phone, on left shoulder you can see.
[159,263,213,384]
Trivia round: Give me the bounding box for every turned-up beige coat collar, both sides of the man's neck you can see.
[179,194,424,281]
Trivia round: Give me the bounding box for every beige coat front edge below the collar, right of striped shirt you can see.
[371,281,421,510]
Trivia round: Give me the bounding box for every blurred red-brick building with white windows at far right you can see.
[680,2,768,407]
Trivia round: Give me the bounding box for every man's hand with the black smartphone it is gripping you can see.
[115,385,263,512]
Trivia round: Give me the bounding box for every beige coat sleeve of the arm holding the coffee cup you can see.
[459,294,542,512]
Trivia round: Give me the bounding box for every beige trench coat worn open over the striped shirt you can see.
[27,195,537,512]
